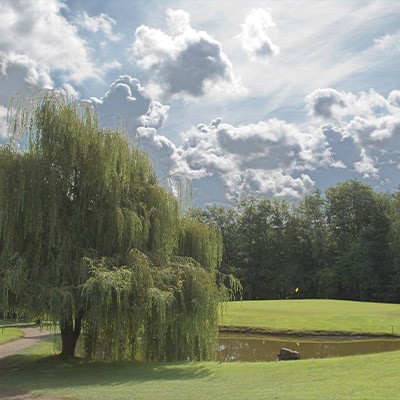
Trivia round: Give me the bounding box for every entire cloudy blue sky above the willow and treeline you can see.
[0,0,400,206]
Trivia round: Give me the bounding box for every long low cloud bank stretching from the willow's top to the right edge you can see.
[54,75,400,206]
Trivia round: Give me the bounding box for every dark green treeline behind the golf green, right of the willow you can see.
[192,180,400,302]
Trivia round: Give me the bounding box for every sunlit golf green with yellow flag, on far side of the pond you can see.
[220,300,400,335]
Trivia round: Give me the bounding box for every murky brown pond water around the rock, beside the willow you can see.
[217,334,400,361]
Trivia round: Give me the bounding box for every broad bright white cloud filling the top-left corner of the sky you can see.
[0,0,99,82]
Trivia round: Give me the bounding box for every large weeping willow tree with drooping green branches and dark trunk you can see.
[0,91,238,360]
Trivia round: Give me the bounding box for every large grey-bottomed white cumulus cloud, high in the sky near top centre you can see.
[132,9,244,98]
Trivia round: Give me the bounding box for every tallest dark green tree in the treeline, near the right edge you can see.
[326,180,391,301]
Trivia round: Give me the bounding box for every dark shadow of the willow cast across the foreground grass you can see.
[0,355,210,391]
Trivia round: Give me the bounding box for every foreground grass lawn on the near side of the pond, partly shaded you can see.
[0,343,400,400]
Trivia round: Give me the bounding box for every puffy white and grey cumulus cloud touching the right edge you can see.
[306,88,400,180]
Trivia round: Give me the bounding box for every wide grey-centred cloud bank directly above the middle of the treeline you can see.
[177,119,330,201]
